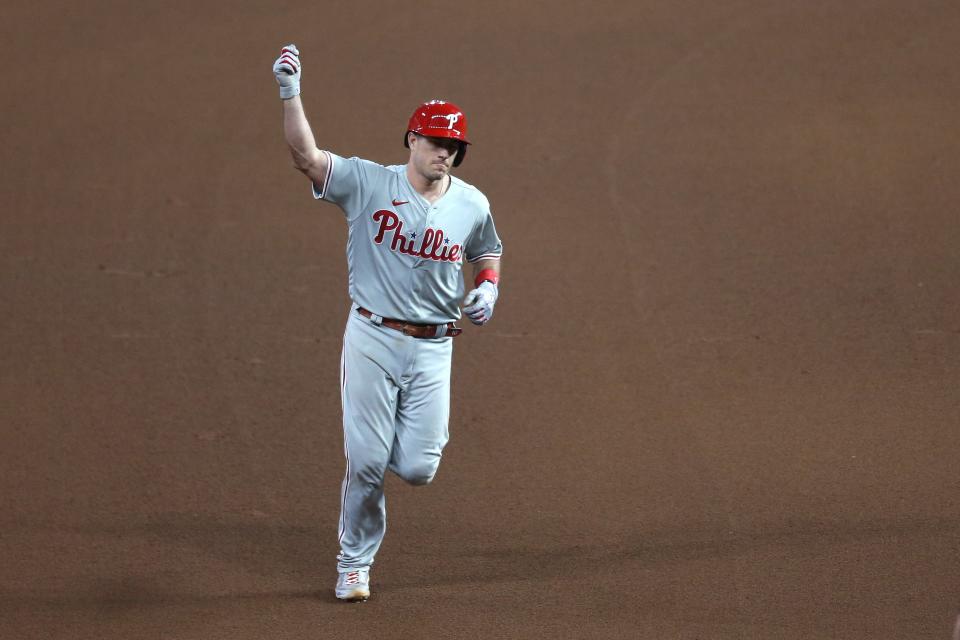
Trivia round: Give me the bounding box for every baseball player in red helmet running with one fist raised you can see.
[273,44,503,600]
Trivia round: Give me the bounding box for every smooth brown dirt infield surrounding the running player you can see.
[0,0,960,640]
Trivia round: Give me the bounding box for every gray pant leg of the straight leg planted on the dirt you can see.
[338,312,402,571]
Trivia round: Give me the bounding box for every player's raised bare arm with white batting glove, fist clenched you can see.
[273,44,330,192]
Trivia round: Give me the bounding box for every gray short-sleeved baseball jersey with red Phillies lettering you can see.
[313,152,503,324]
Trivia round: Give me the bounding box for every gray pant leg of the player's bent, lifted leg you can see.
[390,338,453,485]
